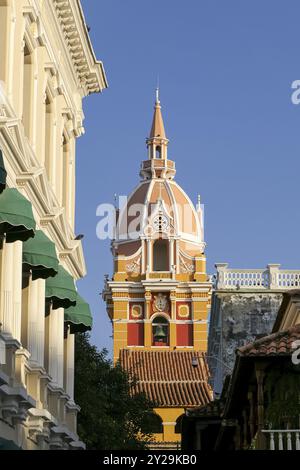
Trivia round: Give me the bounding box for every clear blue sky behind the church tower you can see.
[76,0,300,349]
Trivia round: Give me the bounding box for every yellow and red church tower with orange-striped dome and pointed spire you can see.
[103,91,211,448]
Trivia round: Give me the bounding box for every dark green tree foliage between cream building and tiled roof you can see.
[75,333,153,450]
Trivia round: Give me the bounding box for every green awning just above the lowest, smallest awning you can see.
[46,266,77,309]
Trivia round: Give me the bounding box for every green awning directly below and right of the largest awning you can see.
[23,230,58,280]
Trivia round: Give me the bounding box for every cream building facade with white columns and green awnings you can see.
[0,0,107,450]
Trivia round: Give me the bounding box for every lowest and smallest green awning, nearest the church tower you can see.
[65,294,93,333]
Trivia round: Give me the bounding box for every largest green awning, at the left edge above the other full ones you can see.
[0,188,35,243]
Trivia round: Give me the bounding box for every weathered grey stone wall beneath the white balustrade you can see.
[208,292,282,393]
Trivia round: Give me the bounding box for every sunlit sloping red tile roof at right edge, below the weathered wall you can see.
[237,324,300,356]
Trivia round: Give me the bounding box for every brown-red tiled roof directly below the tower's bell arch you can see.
[120,349,212,407]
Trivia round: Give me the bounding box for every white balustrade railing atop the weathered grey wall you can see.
[213,263,300,290]
